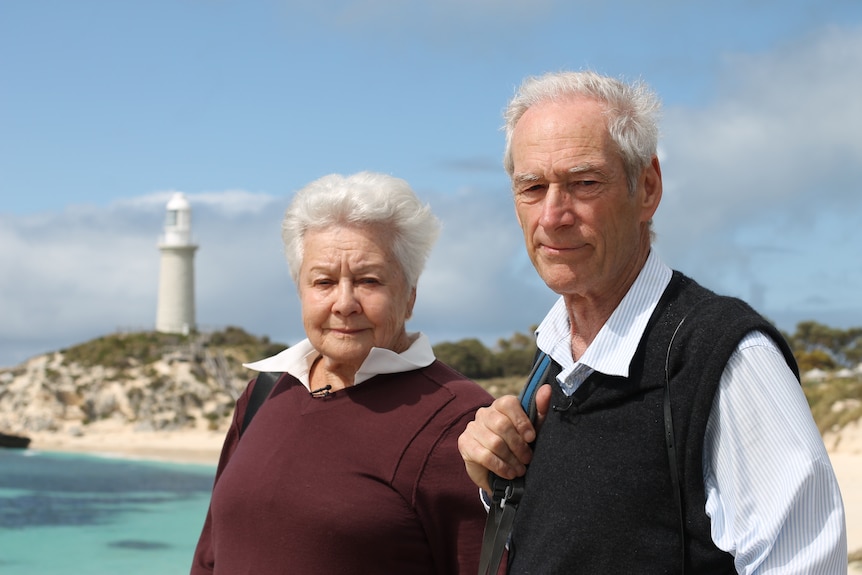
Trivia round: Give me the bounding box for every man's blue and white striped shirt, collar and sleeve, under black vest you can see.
[536,250,847,575]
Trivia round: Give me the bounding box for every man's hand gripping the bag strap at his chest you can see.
[458,385,551,493]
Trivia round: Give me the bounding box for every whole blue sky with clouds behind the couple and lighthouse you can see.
[0,0,862,365]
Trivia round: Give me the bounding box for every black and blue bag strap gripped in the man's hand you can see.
[479,352,555,575]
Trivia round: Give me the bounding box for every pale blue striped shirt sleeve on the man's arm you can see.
[703,332,847,575]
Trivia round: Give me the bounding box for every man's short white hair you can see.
[503,71,661,193]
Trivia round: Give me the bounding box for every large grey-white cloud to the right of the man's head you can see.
[656,28,862,323]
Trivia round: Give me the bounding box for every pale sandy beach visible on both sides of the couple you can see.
[25,422,862,574]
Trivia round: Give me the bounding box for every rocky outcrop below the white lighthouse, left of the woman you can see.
[0,332,288,435]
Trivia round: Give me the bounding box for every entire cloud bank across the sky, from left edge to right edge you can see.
[0,24,862,365]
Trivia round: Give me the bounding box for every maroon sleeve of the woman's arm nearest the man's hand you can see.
[416,410,486,574]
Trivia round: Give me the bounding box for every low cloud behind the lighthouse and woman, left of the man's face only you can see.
[0,182,552,365]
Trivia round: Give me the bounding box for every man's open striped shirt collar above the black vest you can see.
[536,250,673,381]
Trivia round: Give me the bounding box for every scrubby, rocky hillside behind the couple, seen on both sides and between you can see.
[0,322,862,434]
